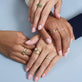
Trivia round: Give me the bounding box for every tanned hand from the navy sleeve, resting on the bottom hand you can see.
[39,16,74,56]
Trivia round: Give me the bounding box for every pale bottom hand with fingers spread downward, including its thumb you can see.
[26,35,62,81]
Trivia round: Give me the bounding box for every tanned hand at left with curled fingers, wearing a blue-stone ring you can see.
[0,31,35,64]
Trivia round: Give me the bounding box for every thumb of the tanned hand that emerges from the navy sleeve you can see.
[39,28,52,44]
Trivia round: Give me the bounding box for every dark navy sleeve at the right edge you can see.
[68,13,82,39]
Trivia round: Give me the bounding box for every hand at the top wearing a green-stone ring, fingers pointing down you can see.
[29,0,62,32]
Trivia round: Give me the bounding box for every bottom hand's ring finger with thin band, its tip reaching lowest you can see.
[34,52,56,81]
